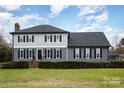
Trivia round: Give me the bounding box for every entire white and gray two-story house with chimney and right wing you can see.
[11,23,110,62]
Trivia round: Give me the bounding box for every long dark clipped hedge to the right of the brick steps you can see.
[39,61,124,69]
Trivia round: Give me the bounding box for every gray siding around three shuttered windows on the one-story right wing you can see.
[68,48,108,62]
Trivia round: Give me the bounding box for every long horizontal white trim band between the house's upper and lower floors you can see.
[14,46,67,48]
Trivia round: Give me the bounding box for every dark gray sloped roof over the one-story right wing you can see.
[68,32,111,47]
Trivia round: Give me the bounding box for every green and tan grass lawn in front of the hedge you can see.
[0,69,124,88]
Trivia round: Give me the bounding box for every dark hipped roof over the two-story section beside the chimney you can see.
[10,25,69,34]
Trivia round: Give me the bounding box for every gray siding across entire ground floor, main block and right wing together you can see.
[13,48,108,62]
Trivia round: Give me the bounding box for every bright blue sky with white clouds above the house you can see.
[0,5,124,46]
